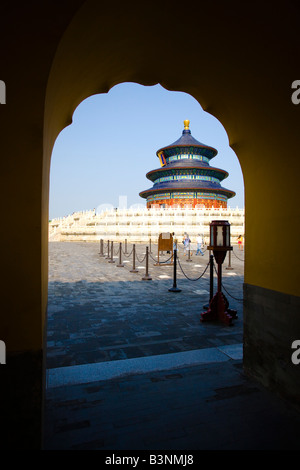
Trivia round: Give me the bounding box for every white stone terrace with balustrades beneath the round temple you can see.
[49,208,244,244]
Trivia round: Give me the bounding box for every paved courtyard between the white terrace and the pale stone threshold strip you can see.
[47,242,243,368]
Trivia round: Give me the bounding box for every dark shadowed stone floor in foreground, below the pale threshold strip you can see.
[45,361,300,452]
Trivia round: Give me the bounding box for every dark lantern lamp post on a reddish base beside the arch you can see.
[201,220,237,325]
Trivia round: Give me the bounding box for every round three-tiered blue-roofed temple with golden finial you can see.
[140,120,235,208]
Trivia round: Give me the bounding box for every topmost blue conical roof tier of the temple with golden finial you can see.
[156,119,218,159]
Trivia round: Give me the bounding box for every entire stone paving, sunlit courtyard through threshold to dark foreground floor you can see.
[44,242,300,450]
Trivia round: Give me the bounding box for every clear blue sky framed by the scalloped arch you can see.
[49,83,244,219]
